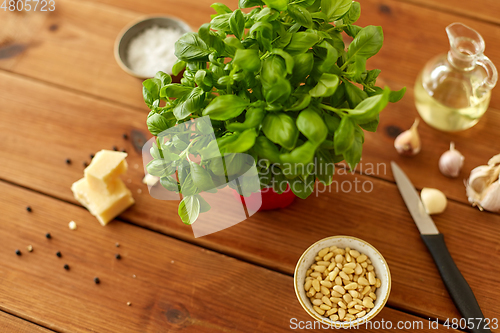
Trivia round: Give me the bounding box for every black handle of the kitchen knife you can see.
[421,234,491,333]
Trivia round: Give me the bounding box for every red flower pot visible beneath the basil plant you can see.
[233,185,296,211]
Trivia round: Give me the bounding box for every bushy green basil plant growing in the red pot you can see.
[143,0,405,223]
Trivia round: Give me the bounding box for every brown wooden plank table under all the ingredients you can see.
[0,0,500,332]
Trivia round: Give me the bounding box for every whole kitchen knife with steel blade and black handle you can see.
[391,162,491,333]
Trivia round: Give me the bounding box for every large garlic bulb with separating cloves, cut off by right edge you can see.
[465,154,500,213]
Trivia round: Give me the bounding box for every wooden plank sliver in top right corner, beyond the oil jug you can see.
[392,0,500,24]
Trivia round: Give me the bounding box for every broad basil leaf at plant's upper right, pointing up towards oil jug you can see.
[347,25,384,59]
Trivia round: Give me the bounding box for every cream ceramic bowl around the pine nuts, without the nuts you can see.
[294,236,391,328]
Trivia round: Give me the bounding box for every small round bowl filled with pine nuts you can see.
[294,236,391,328]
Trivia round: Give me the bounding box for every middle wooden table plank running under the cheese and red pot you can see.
[0,70,500,319]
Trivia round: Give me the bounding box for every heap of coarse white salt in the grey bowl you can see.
[127,26,184,77]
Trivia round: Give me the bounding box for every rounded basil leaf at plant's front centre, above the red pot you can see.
[262,112,299,150]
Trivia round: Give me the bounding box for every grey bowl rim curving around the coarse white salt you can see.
[114,15,192,79]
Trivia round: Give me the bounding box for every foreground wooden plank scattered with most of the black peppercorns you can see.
[0,182,458,332]
